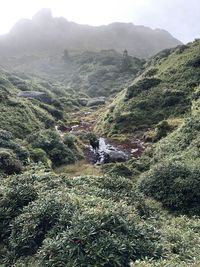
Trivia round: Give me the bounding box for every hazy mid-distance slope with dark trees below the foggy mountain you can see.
[3,49,145,97]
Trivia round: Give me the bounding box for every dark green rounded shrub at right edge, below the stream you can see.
[139,159,200,214]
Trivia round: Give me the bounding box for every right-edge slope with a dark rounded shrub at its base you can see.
[139,87,200,215]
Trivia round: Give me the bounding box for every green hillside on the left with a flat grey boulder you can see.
[0,70,88,139]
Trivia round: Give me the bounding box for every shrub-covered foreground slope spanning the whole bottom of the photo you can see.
[0,164,200,267]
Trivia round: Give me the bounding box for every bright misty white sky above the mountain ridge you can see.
[0,0,200,42]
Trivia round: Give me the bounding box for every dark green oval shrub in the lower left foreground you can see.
[9,198,63,258]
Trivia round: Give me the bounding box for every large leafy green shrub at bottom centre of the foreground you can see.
[39,211,162,267]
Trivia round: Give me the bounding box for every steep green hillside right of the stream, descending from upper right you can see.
[96,40,200,135]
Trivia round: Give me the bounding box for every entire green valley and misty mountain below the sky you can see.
[0,10,200,267]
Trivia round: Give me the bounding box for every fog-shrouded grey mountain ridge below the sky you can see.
[0,9,181,57]
